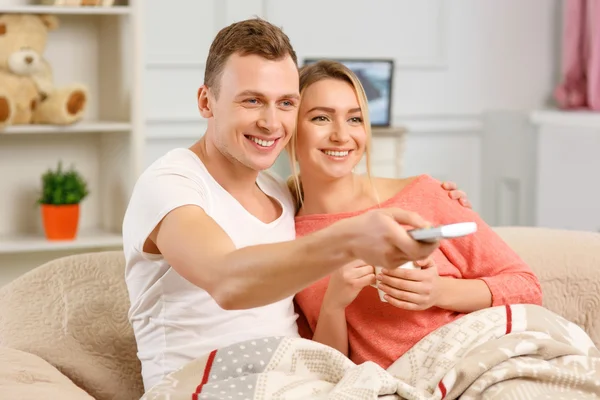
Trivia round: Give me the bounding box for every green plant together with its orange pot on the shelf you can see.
[38,162,89,240]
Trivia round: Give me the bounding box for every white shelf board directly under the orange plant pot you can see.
[0,230,123,254]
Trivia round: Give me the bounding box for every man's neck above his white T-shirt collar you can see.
[190,135,258,194]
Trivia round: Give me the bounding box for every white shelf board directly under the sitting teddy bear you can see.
[0,121,131,137]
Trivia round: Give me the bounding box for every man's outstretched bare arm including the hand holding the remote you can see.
[149,206,437,309]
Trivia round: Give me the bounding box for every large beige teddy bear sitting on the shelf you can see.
[0,14,88,130]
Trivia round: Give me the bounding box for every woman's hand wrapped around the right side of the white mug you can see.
[377,257,441,311]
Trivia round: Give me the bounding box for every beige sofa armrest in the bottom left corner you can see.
[0,347,94,400]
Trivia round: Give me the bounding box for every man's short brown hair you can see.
[204,18,298,96]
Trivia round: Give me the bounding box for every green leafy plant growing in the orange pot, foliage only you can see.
[38,161,89,205]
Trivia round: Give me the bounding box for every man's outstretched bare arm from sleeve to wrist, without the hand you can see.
[150,206,351,309]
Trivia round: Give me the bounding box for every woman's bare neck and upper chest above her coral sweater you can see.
[298,174,377,215]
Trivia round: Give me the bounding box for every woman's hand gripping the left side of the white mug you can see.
[323,260,375,310]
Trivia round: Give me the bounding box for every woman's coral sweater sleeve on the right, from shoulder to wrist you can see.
[412,178,542,306]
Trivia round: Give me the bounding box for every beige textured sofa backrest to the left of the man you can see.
[0,251,143,400]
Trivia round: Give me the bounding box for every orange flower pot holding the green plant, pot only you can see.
[41,204,79,240]
